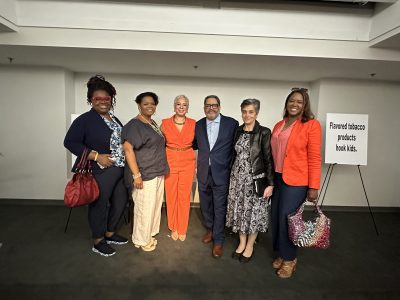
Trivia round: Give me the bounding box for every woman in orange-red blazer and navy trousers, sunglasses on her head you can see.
[271,88,321,278]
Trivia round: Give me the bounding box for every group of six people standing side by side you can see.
[64,75,321,278]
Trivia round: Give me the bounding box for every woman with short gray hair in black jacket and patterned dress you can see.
[226,99,274,263]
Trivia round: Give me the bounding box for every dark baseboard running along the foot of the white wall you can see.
[0,198,400,213]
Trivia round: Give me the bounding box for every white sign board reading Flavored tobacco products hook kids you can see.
[325,113,368,166]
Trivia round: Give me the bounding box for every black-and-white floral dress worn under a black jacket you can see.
[226,132,269,234]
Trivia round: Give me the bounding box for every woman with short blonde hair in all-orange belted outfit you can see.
[161,95,196,241]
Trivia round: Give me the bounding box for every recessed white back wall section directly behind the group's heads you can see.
[75,73,308,127]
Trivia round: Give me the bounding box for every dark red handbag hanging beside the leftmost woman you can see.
[64,149,100,207]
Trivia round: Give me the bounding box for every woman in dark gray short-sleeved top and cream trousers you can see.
[121,92,169,251]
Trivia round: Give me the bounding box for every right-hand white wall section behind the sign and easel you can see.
[318,79,400,207]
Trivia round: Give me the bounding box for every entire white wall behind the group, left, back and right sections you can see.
[0,67,400,207]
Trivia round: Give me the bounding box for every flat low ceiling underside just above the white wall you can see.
[0,46,400,82]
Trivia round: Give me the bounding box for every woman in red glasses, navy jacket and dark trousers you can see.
[64,75,128,256]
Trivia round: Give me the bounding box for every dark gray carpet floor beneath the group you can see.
[0,203,400,300]
